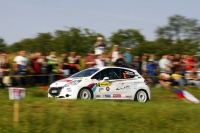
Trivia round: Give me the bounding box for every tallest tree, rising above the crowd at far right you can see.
[156,15,200,42]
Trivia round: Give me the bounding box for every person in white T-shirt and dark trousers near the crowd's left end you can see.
[13,50,28,86]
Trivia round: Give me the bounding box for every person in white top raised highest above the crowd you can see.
[94,37,105,55]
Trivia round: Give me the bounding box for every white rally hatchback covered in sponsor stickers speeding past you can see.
[48,67,151,102]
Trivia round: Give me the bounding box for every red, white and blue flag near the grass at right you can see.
[174,90,200,103]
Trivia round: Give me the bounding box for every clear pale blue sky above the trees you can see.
[0,0,200,44]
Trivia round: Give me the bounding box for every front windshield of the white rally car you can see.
[69,68,99,78]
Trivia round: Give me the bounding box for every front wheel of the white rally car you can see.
[78,88,93,100]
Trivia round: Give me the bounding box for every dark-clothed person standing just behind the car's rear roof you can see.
[130,56,142,74]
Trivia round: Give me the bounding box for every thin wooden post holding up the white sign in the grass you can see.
[13,100,19,126]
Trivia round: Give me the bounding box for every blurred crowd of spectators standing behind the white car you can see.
[0,37,200,88]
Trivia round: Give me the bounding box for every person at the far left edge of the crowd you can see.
[0,53,10,88]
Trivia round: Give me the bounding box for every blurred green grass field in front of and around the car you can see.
[0,88,200,133]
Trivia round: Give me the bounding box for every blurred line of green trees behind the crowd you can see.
[0,15,200,56]
